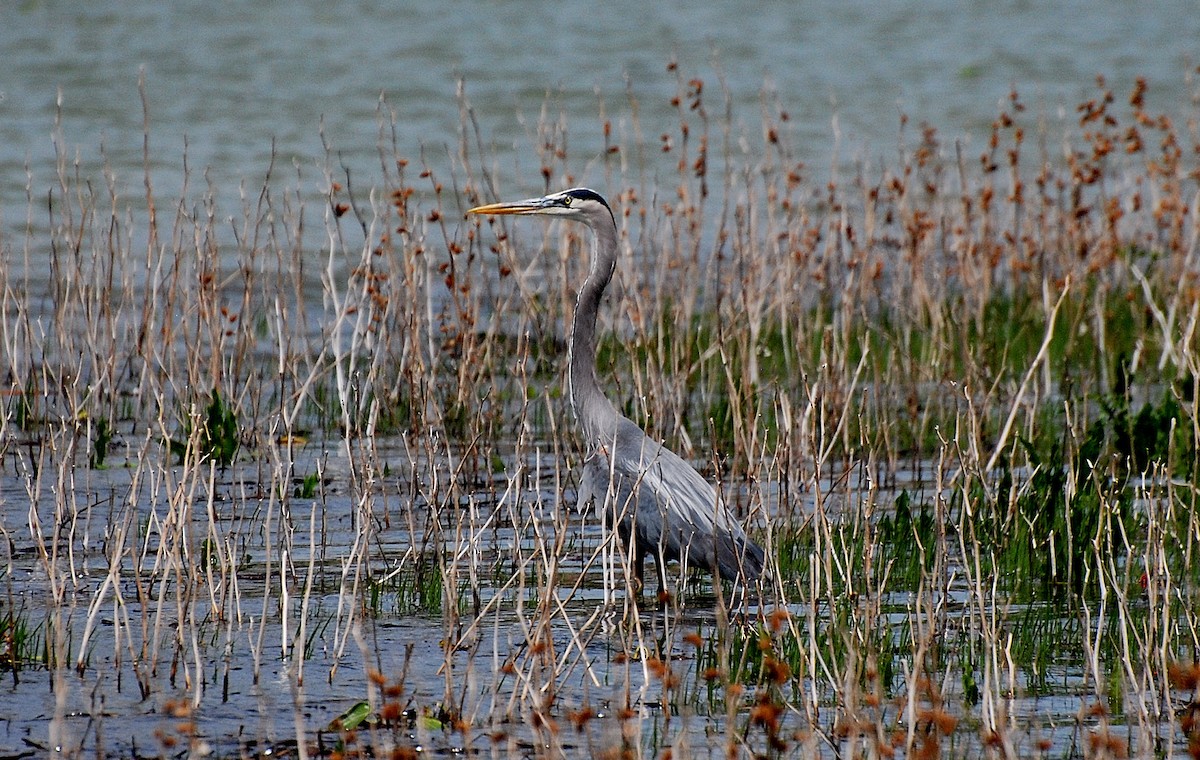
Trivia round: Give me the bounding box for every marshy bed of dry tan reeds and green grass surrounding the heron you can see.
[0,64,1200,758]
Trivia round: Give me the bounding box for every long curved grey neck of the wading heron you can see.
[568,214,618,443]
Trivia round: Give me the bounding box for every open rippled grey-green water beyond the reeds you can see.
[0,0,1200,229]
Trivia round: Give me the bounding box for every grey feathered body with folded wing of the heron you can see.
[580,419,764,581]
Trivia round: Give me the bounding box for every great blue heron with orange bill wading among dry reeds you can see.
[468,187,764,592]
